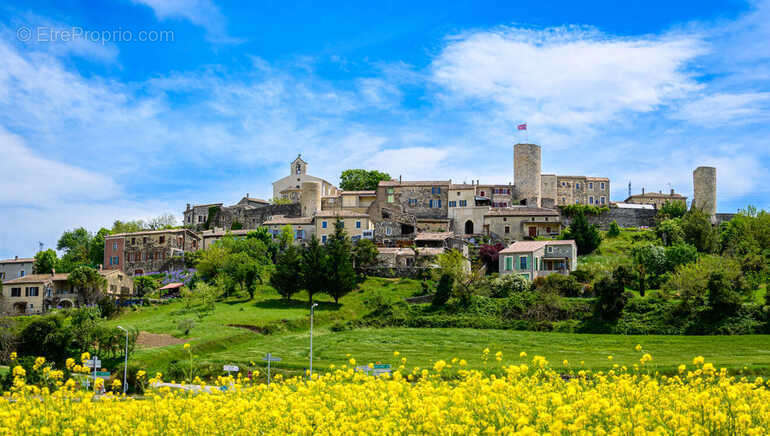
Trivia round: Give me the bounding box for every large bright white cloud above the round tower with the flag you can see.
[431,27,704,130]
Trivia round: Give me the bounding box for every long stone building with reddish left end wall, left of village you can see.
[104,229,202,276]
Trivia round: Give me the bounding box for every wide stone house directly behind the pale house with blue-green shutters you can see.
[484,206,562,242]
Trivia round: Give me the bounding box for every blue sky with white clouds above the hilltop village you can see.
[0,0,770,258]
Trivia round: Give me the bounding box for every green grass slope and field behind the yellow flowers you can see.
[103,278,770,374]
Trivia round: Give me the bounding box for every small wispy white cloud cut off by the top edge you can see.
[133,0,240,43]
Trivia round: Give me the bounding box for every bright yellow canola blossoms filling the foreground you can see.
[0,352,770,436]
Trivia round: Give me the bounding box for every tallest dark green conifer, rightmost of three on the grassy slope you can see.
[326,220,358,303]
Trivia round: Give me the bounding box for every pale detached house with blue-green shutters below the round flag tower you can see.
[499,240,577,280]
